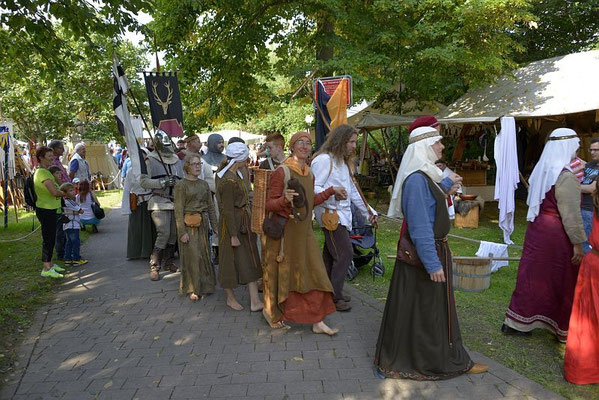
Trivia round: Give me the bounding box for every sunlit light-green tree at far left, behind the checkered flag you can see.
[0,33,147,141]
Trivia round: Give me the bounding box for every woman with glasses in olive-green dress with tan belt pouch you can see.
[175,154,216,301]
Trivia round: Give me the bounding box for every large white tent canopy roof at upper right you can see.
[437,50,599,123]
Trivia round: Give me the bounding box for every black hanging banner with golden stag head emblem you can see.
[144,72,183,137]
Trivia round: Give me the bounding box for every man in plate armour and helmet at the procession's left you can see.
[140,130,184,281]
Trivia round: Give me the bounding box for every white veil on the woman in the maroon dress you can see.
[526,128,580,222]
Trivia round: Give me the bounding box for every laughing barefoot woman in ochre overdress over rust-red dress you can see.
[263,132,347,335]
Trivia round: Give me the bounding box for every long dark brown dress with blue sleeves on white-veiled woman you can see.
[374,171,474,380]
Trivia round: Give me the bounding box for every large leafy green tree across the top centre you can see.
[151,0,532,125]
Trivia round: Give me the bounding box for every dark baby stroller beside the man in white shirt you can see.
[346,204,385,281]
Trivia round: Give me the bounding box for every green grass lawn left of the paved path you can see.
[0,190,121,386]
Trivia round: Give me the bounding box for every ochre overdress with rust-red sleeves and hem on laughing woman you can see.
[263,161,335,324]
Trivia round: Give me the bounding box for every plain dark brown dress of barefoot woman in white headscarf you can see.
[216,170,262,289]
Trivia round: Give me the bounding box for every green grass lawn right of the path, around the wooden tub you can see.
[315,202,599,399]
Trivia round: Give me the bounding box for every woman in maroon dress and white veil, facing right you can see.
[501,128,586,342]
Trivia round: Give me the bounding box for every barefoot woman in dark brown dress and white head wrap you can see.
[216,142,264,311]
